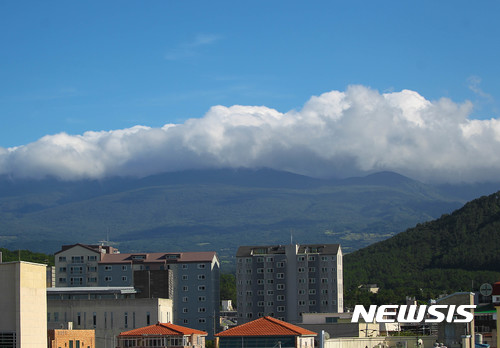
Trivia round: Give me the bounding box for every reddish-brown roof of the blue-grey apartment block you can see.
[99,251,217,263]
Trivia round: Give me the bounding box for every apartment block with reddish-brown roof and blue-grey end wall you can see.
[98,251,220,339]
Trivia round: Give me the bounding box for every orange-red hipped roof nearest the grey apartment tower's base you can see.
[215,317,317,337]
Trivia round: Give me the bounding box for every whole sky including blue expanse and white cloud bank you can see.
[0,0,500,182]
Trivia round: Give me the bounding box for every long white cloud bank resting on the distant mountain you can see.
[0,86,500,182]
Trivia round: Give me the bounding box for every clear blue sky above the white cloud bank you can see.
[0,1,500,147]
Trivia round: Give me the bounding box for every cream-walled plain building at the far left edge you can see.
[0,261,47,348]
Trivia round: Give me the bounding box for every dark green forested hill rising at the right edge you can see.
[344,192,500,304]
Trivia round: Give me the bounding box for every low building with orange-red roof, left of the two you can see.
[116,323,207,348]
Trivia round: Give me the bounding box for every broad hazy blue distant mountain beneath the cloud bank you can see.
[0,168,500,265]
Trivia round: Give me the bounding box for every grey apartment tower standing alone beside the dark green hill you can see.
[236,244,343,324]
